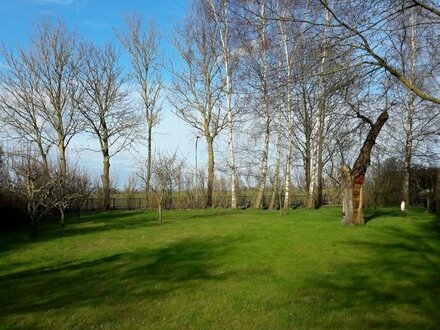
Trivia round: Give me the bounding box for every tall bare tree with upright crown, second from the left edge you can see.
[25,19,81,174]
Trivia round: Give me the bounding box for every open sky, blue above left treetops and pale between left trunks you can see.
[0,0,206,188]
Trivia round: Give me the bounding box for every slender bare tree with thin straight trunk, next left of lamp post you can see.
[116,14,162,206]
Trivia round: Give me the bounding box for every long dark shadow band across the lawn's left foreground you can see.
[0,240,235,323]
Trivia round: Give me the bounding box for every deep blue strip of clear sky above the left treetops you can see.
[0,0,189,43]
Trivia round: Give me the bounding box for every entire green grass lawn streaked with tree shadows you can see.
[0,209,440,329]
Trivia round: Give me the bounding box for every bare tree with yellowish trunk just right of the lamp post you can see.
[168,2,227,207]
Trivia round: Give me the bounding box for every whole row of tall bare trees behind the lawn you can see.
[0,0,440,232]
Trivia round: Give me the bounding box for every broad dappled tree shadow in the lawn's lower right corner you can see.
[304,221,440,329]
